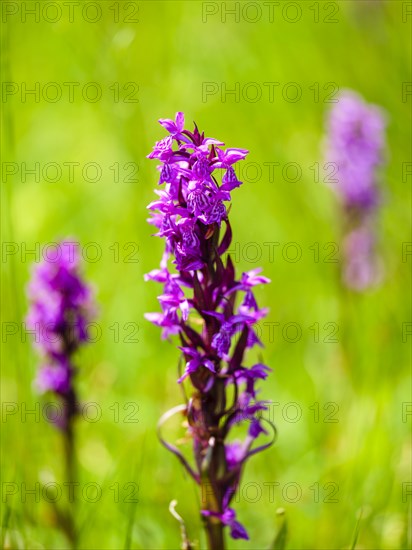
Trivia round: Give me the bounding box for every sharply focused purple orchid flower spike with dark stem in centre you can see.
[145,113,270,548]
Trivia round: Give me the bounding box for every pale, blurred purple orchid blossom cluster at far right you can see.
[326,91,386,291]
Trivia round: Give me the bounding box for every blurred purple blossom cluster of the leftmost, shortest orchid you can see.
[27,241,94,426]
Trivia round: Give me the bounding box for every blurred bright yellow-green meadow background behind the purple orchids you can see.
[1,0,412,549]
